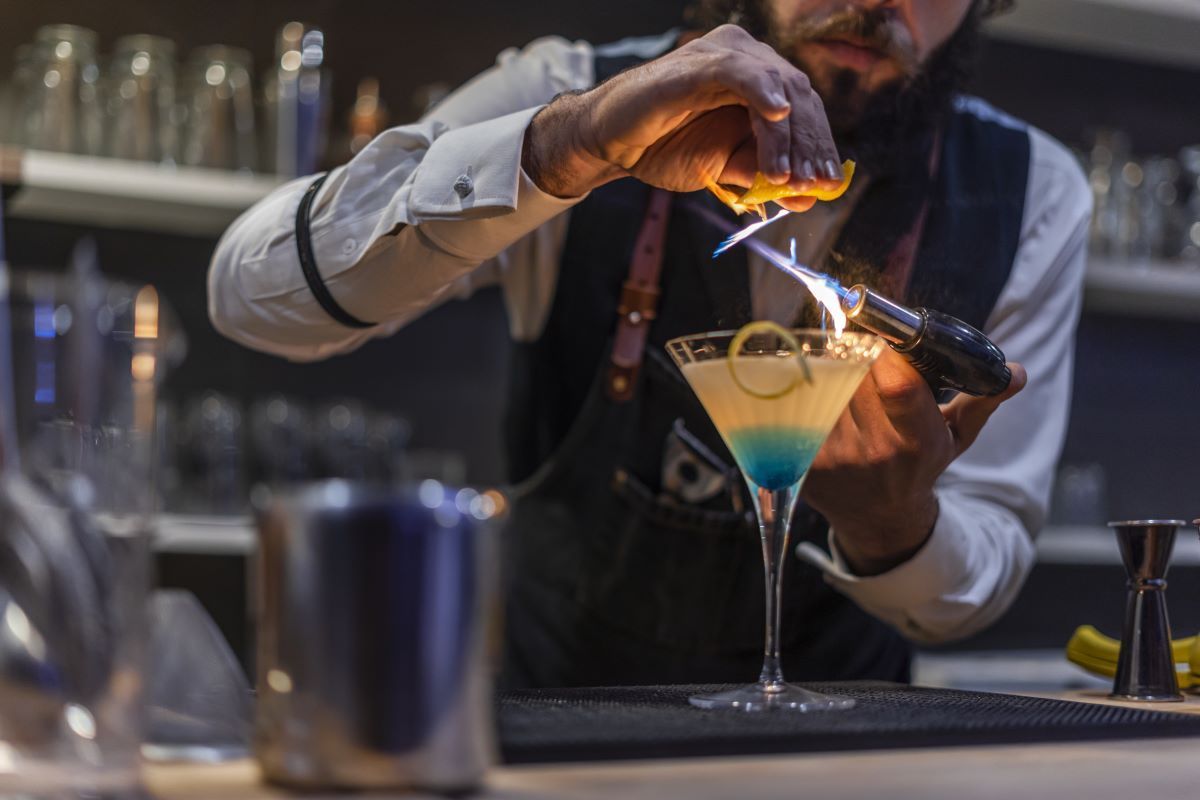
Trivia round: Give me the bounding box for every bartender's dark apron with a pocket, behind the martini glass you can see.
[504,181,908,687]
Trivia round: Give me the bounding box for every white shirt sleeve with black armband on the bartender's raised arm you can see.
[209,38,592,361]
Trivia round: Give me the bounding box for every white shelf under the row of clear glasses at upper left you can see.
[0,149,282,236]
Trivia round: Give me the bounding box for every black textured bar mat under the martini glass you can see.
[499,681,1200,764]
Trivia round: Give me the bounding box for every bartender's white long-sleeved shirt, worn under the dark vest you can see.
[209,38,1091,642]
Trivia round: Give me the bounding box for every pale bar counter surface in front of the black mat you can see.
[145,692,1200,800]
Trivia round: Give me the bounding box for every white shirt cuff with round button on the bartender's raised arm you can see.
[408,107,586,261]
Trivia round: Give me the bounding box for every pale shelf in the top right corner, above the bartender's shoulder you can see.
[985,0,1200,68]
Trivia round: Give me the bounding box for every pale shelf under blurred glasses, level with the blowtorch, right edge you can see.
[1084,256,1200,320]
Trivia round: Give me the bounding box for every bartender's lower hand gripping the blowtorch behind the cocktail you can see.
[803,349,1026,575]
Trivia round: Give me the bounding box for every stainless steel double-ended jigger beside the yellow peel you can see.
[1109,519,1187,702]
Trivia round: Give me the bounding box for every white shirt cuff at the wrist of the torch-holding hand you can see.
[797,503,972,639]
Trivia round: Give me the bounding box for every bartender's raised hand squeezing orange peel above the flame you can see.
[522,25,841,205]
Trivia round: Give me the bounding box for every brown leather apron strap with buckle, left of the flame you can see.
[606,188,671,403]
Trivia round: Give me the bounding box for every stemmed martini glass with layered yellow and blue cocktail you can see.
[666,324,884,711]
